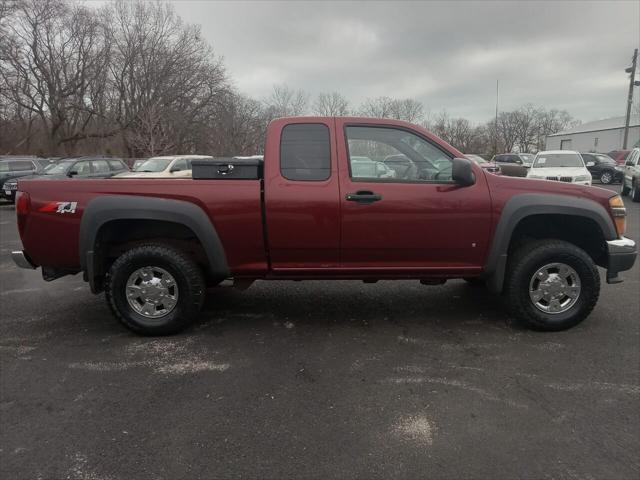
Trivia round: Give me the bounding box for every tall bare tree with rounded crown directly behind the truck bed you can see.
[104,0,229,156]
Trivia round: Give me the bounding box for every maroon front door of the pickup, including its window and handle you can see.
[336,120,491,275]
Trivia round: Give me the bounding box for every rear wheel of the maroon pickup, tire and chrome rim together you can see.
[105,244,205,335]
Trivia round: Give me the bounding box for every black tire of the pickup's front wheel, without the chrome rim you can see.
[504,239,600,331]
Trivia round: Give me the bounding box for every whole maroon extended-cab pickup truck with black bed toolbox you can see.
[13,117,636,335]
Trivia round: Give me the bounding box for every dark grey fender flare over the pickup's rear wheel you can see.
[78,195,230,293]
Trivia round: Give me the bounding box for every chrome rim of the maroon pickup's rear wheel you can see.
[126,266,178,318]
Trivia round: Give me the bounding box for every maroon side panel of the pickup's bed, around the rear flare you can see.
[19,178,267,276]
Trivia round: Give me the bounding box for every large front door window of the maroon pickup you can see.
[346,126,451,182]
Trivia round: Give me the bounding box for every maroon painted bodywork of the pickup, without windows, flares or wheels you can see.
[13,117,612,278]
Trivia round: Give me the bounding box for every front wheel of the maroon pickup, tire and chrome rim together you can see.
[505,239,600,331]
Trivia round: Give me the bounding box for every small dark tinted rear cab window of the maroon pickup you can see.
[280,123,331,182]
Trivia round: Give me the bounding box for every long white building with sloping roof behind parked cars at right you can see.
[546,115,640,153]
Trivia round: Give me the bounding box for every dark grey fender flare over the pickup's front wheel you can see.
[484,193,618,293]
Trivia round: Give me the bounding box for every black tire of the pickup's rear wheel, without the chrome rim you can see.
[105,244,206,336]
